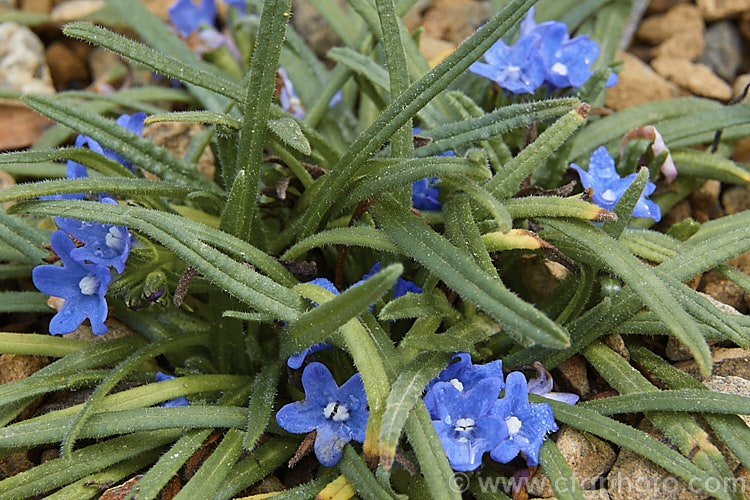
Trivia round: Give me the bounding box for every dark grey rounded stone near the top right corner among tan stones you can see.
[698,21,742,83]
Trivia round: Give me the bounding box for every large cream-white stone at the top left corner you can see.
[0,23,55,94]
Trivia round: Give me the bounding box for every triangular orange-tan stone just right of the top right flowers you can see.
[604,52,681,111]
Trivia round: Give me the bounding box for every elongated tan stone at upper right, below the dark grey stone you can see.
[651,57,732,101]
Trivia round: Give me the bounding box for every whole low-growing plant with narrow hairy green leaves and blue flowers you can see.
[0,0,750,499]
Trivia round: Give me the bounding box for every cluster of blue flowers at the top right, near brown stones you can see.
[469,7,617,94]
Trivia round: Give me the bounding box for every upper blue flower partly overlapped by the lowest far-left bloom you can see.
[55,196,133,273]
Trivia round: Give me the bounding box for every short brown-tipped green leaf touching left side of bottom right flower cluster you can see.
[380,353,450,469]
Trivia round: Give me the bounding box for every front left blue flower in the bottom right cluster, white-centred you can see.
[432,377,508,471]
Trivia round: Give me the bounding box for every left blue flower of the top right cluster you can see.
[469,34,545,94]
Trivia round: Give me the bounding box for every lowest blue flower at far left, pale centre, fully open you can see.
[31,231,111,335]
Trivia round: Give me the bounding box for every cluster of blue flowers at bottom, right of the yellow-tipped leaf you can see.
[423,353,577,471]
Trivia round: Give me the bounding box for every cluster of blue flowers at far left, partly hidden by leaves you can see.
[32,113,146,335]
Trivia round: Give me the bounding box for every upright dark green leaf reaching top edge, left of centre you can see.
[235,0,291,241]
